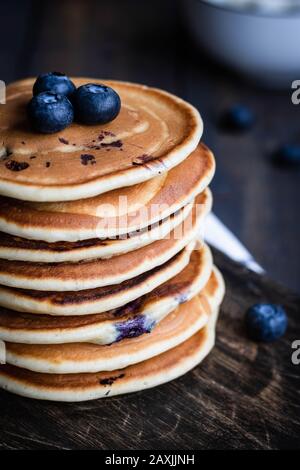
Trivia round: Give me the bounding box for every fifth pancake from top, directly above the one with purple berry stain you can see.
[0,242,212,315]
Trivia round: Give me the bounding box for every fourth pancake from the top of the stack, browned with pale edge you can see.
[0,196,202,292]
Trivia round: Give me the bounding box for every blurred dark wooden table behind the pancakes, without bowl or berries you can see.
[0,0,300,291]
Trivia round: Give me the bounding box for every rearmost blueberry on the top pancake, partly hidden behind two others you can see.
[32,72,76,97]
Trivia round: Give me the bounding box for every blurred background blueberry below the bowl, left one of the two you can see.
[219,104,255,132]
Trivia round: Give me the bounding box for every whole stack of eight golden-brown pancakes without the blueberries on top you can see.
[0,79,224,401]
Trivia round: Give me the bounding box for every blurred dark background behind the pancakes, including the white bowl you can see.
[0,0,300,291]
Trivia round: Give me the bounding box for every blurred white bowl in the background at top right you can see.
[183,0,300,87]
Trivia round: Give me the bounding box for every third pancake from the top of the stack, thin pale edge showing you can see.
[0,188,212,263]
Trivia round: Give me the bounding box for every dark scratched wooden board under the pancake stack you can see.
[0,253,300,450]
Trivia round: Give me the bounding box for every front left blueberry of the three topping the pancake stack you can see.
[27,91,74,134]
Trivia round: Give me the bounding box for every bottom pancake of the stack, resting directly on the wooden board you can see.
[0,308,218,402]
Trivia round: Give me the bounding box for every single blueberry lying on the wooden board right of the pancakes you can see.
[246,303,287,342]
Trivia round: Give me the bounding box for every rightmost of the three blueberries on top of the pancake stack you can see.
[73,83,121,124]
